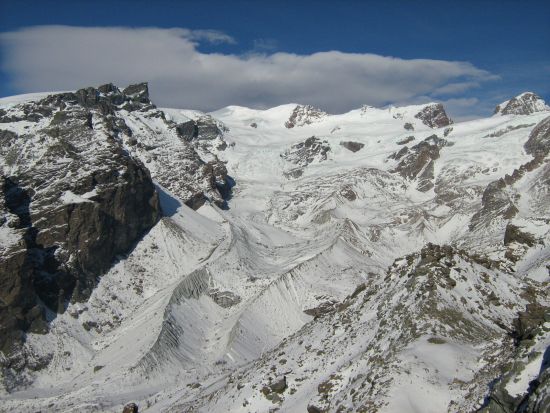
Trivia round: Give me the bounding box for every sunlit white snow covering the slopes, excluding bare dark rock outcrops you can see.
[0,95,550,412]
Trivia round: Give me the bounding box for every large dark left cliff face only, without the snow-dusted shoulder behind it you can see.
[0,84,160,367]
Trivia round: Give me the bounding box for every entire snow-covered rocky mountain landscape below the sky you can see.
[0,84,550,413]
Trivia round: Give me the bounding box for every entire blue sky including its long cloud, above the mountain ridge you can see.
[0,0,550,118]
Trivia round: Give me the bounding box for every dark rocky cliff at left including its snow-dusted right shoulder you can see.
[0,83,237,372]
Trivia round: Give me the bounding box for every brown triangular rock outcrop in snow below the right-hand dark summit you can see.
[390,135,449,192]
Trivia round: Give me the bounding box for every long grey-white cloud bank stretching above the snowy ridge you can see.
[0,26,494,112]
